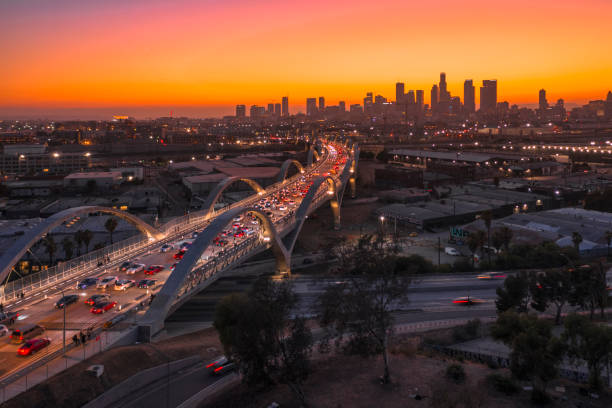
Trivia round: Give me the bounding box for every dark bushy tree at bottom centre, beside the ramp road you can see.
[214,278,313,406]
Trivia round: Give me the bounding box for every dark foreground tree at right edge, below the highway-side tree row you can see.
[561,314,612,389]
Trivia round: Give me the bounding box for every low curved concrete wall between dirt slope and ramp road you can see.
[83,356,202,408]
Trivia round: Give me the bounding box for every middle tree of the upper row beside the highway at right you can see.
[529,269,572,325]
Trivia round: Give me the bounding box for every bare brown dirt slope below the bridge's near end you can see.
[1,329,222,408]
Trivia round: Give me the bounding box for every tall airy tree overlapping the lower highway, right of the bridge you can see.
[319,235,410,383]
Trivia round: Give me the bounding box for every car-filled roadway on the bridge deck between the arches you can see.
[0,140,346,380]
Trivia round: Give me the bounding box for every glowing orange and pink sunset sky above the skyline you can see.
[0,0,612,118]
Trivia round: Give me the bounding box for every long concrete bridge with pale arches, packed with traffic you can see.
[0,141,359,379]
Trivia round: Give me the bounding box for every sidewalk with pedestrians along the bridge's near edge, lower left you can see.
[0,330,125,403]
